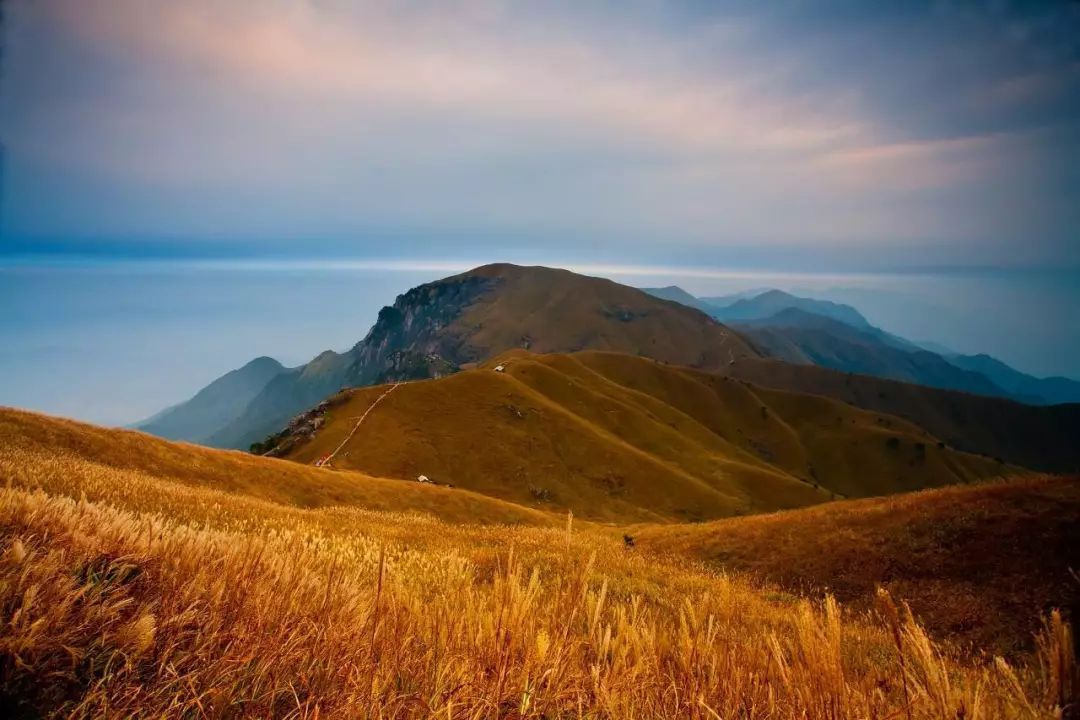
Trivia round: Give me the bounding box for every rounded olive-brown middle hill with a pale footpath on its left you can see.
[286,351,1004,521]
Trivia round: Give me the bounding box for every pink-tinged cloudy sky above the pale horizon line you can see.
[0,0,1080,269]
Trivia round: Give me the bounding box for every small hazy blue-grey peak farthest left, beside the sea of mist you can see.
[135,357,287,443]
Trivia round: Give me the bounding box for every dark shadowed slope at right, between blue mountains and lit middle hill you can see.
[724,358,1080,472]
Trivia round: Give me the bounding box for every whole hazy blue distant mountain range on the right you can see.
[647,286,1080,405]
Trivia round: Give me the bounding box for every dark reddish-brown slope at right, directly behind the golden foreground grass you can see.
[635,477,1080,652]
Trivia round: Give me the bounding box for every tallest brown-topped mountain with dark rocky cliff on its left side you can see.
[179,264,757,448]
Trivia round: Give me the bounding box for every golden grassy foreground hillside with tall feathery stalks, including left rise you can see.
[0,411,1078,720]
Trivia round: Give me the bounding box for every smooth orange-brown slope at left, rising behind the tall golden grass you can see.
[0,407,557,525]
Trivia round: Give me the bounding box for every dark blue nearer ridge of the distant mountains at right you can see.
[733,308,1009,396]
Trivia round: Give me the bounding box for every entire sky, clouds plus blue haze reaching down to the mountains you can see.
[0,0,1080,422]
